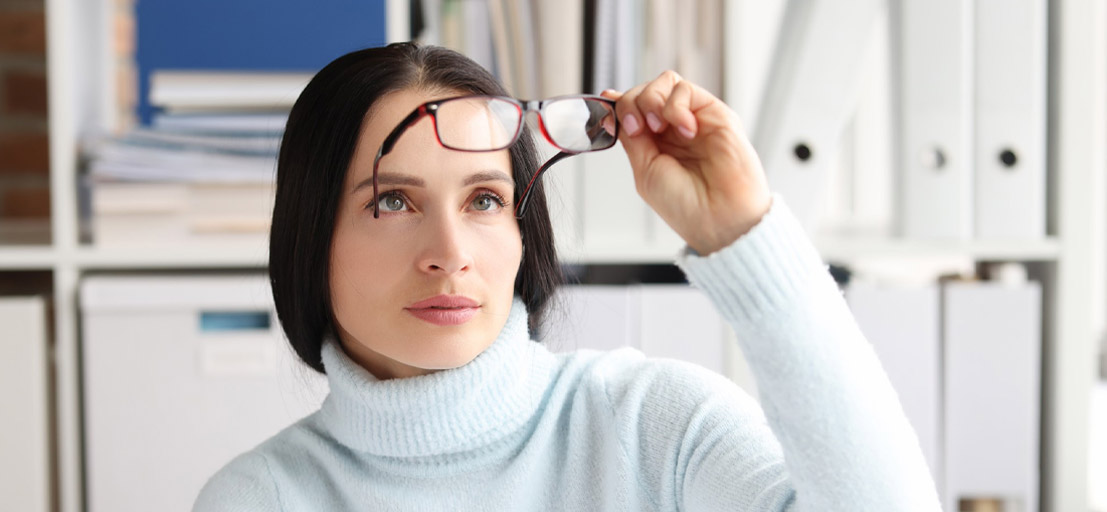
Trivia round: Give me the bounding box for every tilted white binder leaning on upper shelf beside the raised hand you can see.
[752,0,883,230]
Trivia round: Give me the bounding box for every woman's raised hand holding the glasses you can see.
[603,71,772,255]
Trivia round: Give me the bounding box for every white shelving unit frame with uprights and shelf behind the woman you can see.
[0,0,1107,512]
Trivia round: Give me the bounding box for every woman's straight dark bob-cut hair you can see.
[269,43,565,373]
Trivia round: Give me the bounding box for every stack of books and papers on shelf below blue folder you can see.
[87,72,311,247]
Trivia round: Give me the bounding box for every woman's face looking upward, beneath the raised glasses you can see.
[330,90,523,379]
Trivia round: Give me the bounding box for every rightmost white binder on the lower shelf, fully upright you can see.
[943,282,1042,512]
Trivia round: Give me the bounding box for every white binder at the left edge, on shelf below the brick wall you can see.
[0,297,51,512]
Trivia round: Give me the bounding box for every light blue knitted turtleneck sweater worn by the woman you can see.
[194,197,940,512]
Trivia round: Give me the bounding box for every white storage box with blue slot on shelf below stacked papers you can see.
[81,274,327,512]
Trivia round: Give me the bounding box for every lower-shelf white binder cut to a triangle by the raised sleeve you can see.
[846,283,942,482]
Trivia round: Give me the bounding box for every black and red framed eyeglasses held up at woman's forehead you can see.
[373,95,619,219]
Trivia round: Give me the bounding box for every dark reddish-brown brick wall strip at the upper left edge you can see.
[0,0,50,222]
